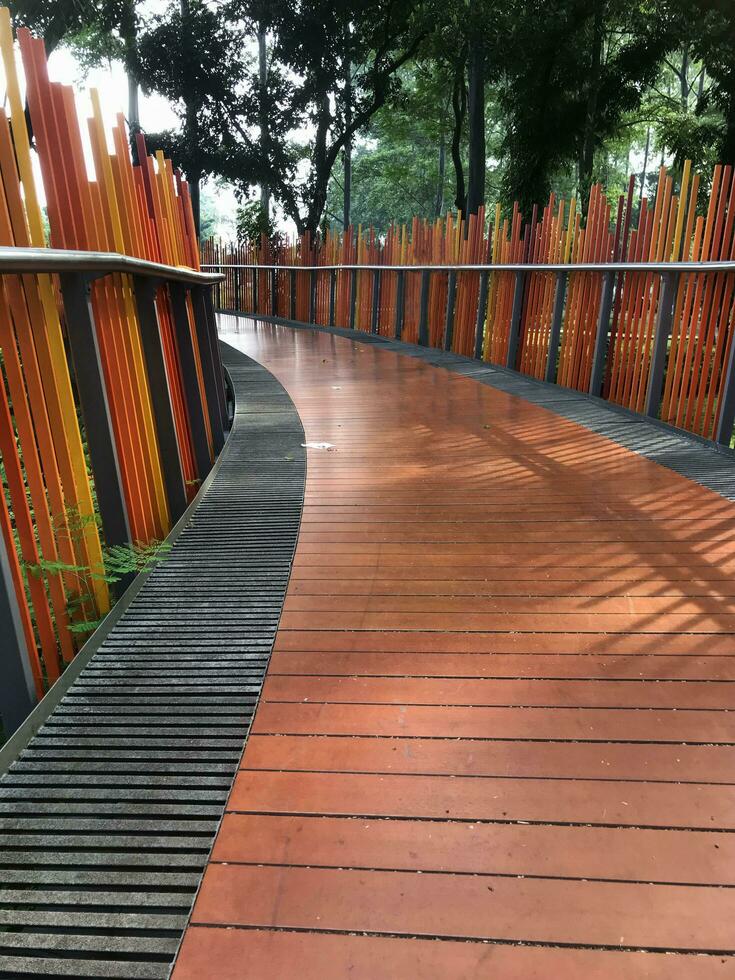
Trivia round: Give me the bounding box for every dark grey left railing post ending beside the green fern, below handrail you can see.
[60,272,131,546]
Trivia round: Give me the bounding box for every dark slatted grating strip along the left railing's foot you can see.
[0,347,306,978]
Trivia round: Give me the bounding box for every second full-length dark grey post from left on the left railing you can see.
[133,276,187,521]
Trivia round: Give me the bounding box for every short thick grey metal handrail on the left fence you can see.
[0,246,224,286]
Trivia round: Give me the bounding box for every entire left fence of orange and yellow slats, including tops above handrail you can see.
[0,7,226,739]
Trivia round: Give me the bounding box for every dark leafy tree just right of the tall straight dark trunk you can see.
[498,0,677,210]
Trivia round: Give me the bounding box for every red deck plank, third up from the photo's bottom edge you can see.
[212,813,735,885]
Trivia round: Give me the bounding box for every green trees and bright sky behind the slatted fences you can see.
[11,0,735,234]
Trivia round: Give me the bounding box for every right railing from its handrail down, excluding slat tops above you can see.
[202,261,735,446]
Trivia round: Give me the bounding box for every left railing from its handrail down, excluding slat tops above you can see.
[0,248,227,735]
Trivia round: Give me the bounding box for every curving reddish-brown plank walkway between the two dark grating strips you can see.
[174,321,735,980]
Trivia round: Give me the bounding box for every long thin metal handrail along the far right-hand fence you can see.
[202,261,735,274]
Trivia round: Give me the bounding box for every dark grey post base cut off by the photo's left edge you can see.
[0,534,36,738]
